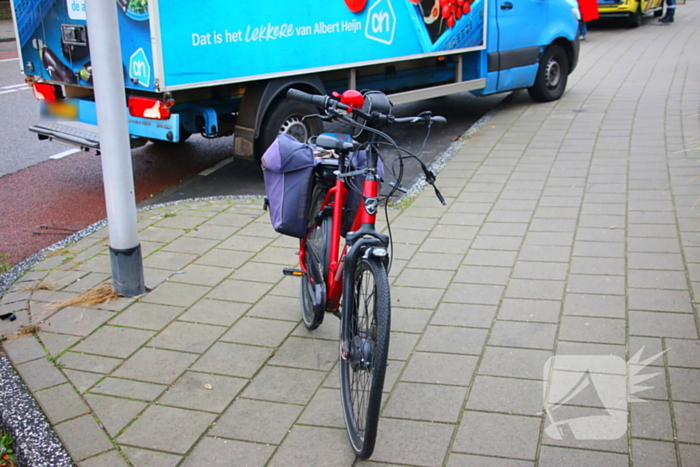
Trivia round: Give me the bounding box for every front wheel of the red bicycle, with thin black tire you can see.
[340,257,391,459]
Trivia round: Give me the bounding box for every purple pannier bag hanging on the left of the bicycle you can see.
[262,134,315,238]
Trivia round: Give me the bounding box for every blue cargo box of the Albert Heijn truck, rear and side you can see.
[15,0,485,91]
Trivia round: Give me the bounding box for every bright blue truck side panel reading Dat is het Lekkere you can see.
[158,0,485,90]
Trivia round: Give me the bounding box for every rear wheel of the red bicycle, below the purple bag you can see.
[301,216,332,331]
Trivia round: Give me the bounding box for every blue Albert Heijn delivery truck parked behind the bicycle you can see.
[12,0,579,161]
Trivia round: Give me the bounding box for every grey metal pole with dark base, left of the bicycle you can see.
[85,0,146,296]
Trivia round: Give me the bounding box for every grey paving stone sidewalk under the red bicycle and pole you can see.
[0,4,700,467]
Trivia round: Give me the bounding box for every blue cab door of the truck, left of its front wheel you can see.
[488,0,548,91]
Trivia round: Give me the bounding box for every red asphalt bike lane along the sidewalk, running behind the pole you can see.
[0,143,235,265]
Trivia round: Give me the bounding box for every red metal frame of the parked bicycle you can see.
[299,145,388,311]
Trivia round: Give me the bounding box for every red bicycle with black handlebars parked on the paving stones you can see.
[278,89,445,459]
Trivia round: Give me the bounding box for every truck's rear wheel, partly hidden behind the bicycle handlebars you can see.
[256,99,323,160]
